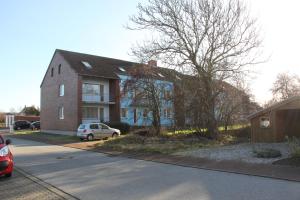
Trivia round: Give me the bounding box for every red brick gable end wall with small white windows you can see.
[40,52,81,131]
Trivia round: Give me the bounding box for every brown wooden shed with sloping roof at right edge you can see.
[249,96,300,142]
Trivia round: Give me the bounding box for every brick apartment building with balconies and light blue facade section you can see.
[40,50,184,133]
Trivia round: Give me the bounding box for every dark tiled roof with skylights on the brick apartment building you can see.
[56,49,181,82]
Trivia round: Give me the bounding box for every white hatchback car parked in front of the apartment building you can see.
[77,123,121,141]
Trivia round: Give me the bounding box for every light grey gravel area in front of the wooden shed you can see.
[175,143,289,164]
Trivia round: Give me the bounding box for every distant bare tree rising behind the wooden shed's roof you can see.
[271,73,300,102]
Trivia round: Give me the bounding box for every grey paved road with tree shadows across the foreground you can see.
[7,139,300,200]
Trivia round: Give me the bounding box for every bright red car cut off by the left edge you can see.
[0,135,14,177]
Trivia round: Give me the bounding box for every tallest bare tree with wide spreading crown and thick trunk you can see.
[129,0,261,137]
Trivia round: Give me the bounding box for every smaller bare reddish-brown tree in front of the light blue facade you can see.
[124,64,172,135]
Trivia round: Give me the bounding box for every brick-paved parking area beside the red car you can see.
[0,170,74,200]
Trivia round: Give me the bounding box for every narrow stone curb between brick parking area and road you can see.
[14,166,80,200]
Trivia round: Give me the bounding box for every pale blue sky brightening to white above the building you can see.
[0,0,300,112]
